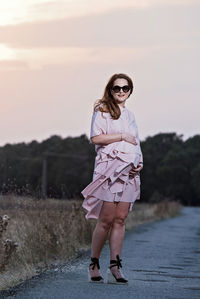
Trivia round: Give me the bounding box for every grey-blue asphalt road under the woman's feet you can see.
[0,208,200,299]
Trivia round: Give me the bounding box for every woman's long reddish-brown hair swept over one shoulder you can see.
[94,73,133,119]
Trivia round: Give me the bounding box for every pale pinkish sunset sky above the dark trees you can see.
[0,0,200,146]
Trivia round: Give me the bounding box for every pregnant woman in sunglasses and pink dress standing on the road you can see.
[81,74,143,284]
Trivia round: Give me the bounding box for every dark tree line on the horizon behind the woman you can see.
[0,133,200,205]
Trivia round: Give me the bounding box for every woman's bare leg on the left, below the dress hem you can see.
[91,201,116,276]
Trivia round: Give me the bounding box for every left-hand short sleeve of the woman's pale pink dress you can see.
[90,111,106,138]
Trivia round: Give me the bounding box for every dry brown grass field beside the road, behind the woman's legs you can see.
[0,196,180,290]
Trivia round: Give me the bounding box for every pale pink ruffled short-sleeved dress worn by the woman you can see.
[81,106,143,219]
